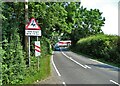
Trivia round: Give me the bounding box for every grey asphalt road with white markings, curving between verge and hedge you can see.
[52,48,120,86]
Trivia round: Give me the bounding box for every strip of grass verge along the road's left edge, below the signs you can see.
[21,55,51,84]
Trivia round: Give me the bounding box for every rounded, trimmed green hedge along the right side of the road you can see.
[74,35,120,65]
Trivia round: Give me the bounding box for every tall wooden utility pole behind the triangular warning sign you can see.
[25,0,30,66]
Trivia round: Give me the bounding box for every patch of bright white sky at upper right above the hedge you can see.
[81,0,120,35]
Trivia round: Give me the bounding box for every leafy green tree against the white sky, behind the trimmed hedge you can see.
[65,2,105,45]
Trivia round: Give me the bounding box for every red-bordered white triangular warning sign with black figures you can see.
[26,18,40,30]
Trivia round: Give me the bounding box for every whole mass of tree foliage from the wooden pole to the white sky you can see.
[26,2,105,44]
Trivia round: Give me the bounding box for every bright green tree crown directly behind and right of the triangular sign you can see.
[28,2,67,42]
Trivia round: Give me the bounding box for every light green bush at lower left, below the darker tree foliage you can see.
[2,30,26,85]
